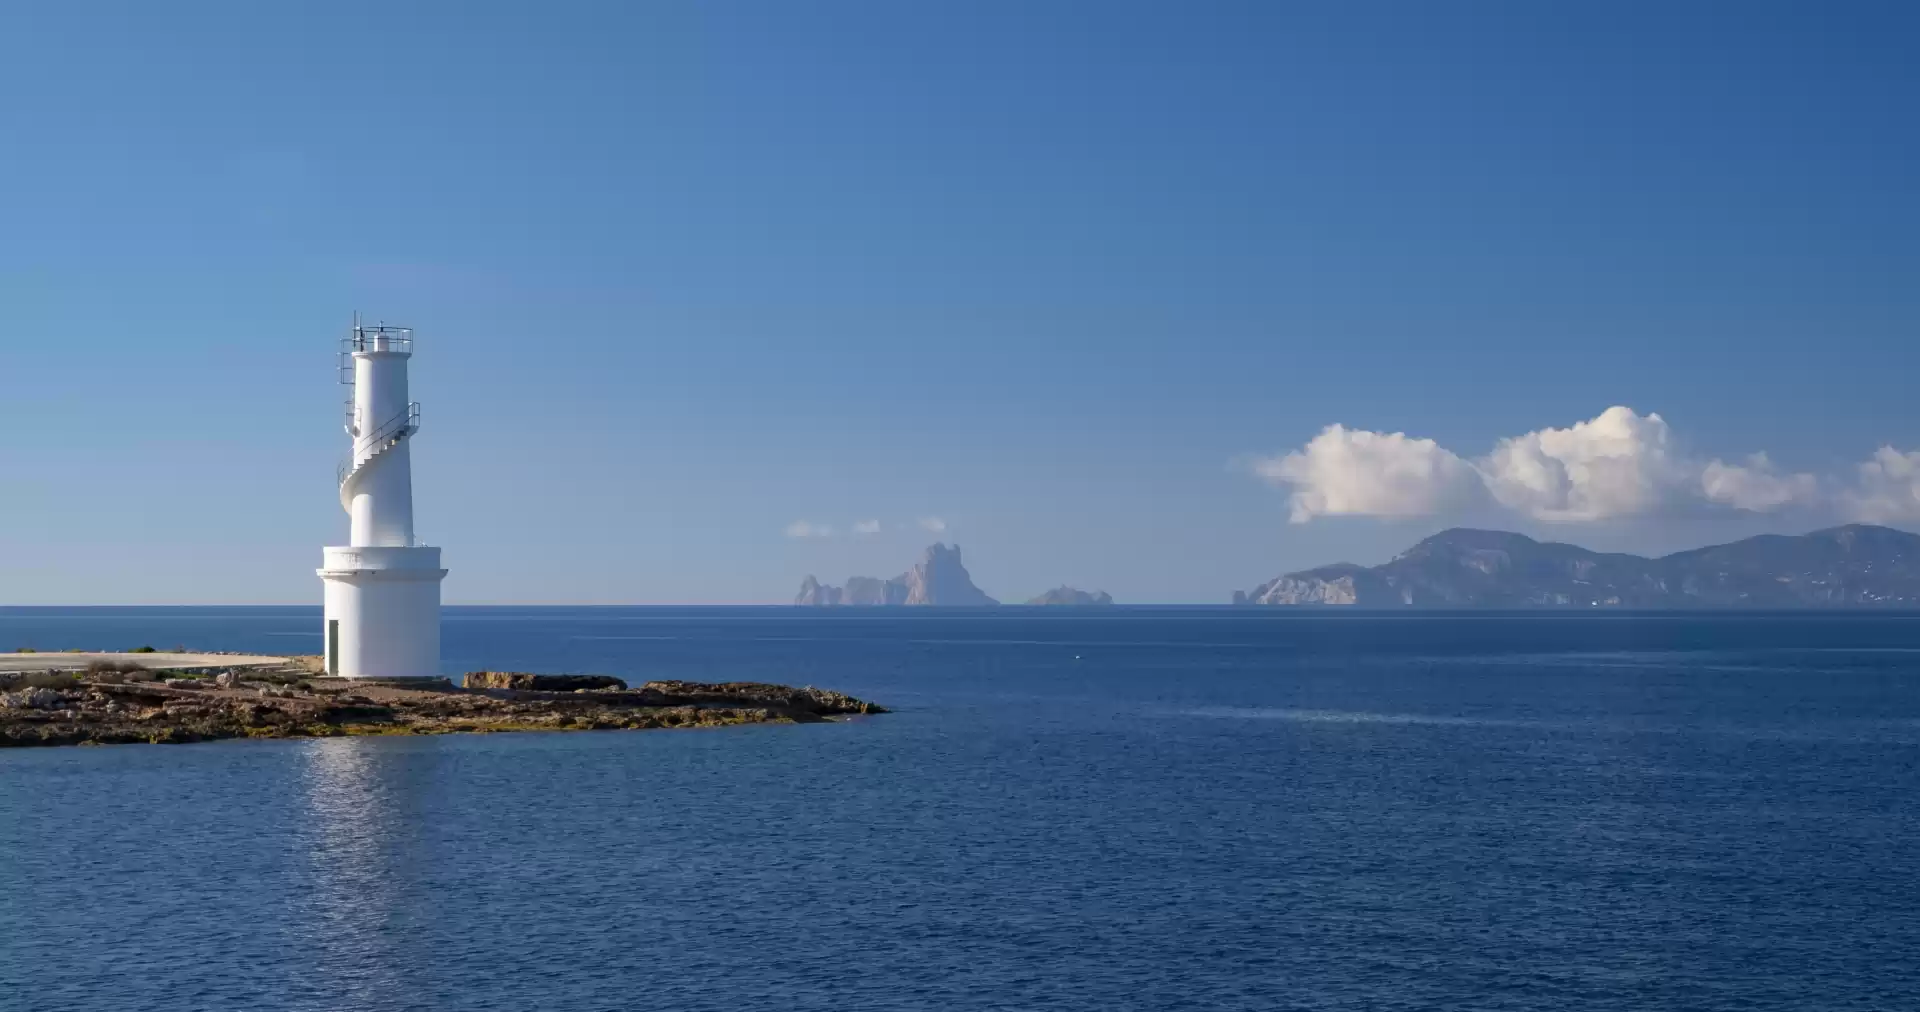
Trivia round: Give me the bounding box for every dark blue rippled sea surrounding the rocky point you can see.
[0,609,1920,1010]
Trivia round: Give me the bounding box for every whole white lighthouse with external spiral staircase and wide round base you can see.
[319,319,447,680]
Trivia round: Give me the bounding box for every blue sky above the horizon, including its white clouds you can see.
[0,2,1920,603]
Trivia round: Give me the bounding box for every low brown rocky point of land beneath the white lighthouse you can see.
[0,659,887,747]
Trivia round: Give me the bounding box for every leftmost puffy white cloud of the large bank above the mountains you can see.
[1254,424,1478,524]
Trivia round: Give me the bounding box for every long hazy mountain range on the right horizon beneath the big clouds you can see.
[1233,524,1920,609]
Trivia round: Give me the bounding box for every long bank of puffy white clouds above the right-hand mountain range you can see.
[1254,407,1896,524]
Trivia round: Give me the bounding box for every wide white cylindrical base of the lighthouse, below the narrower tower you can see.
[317,547,447,680]
